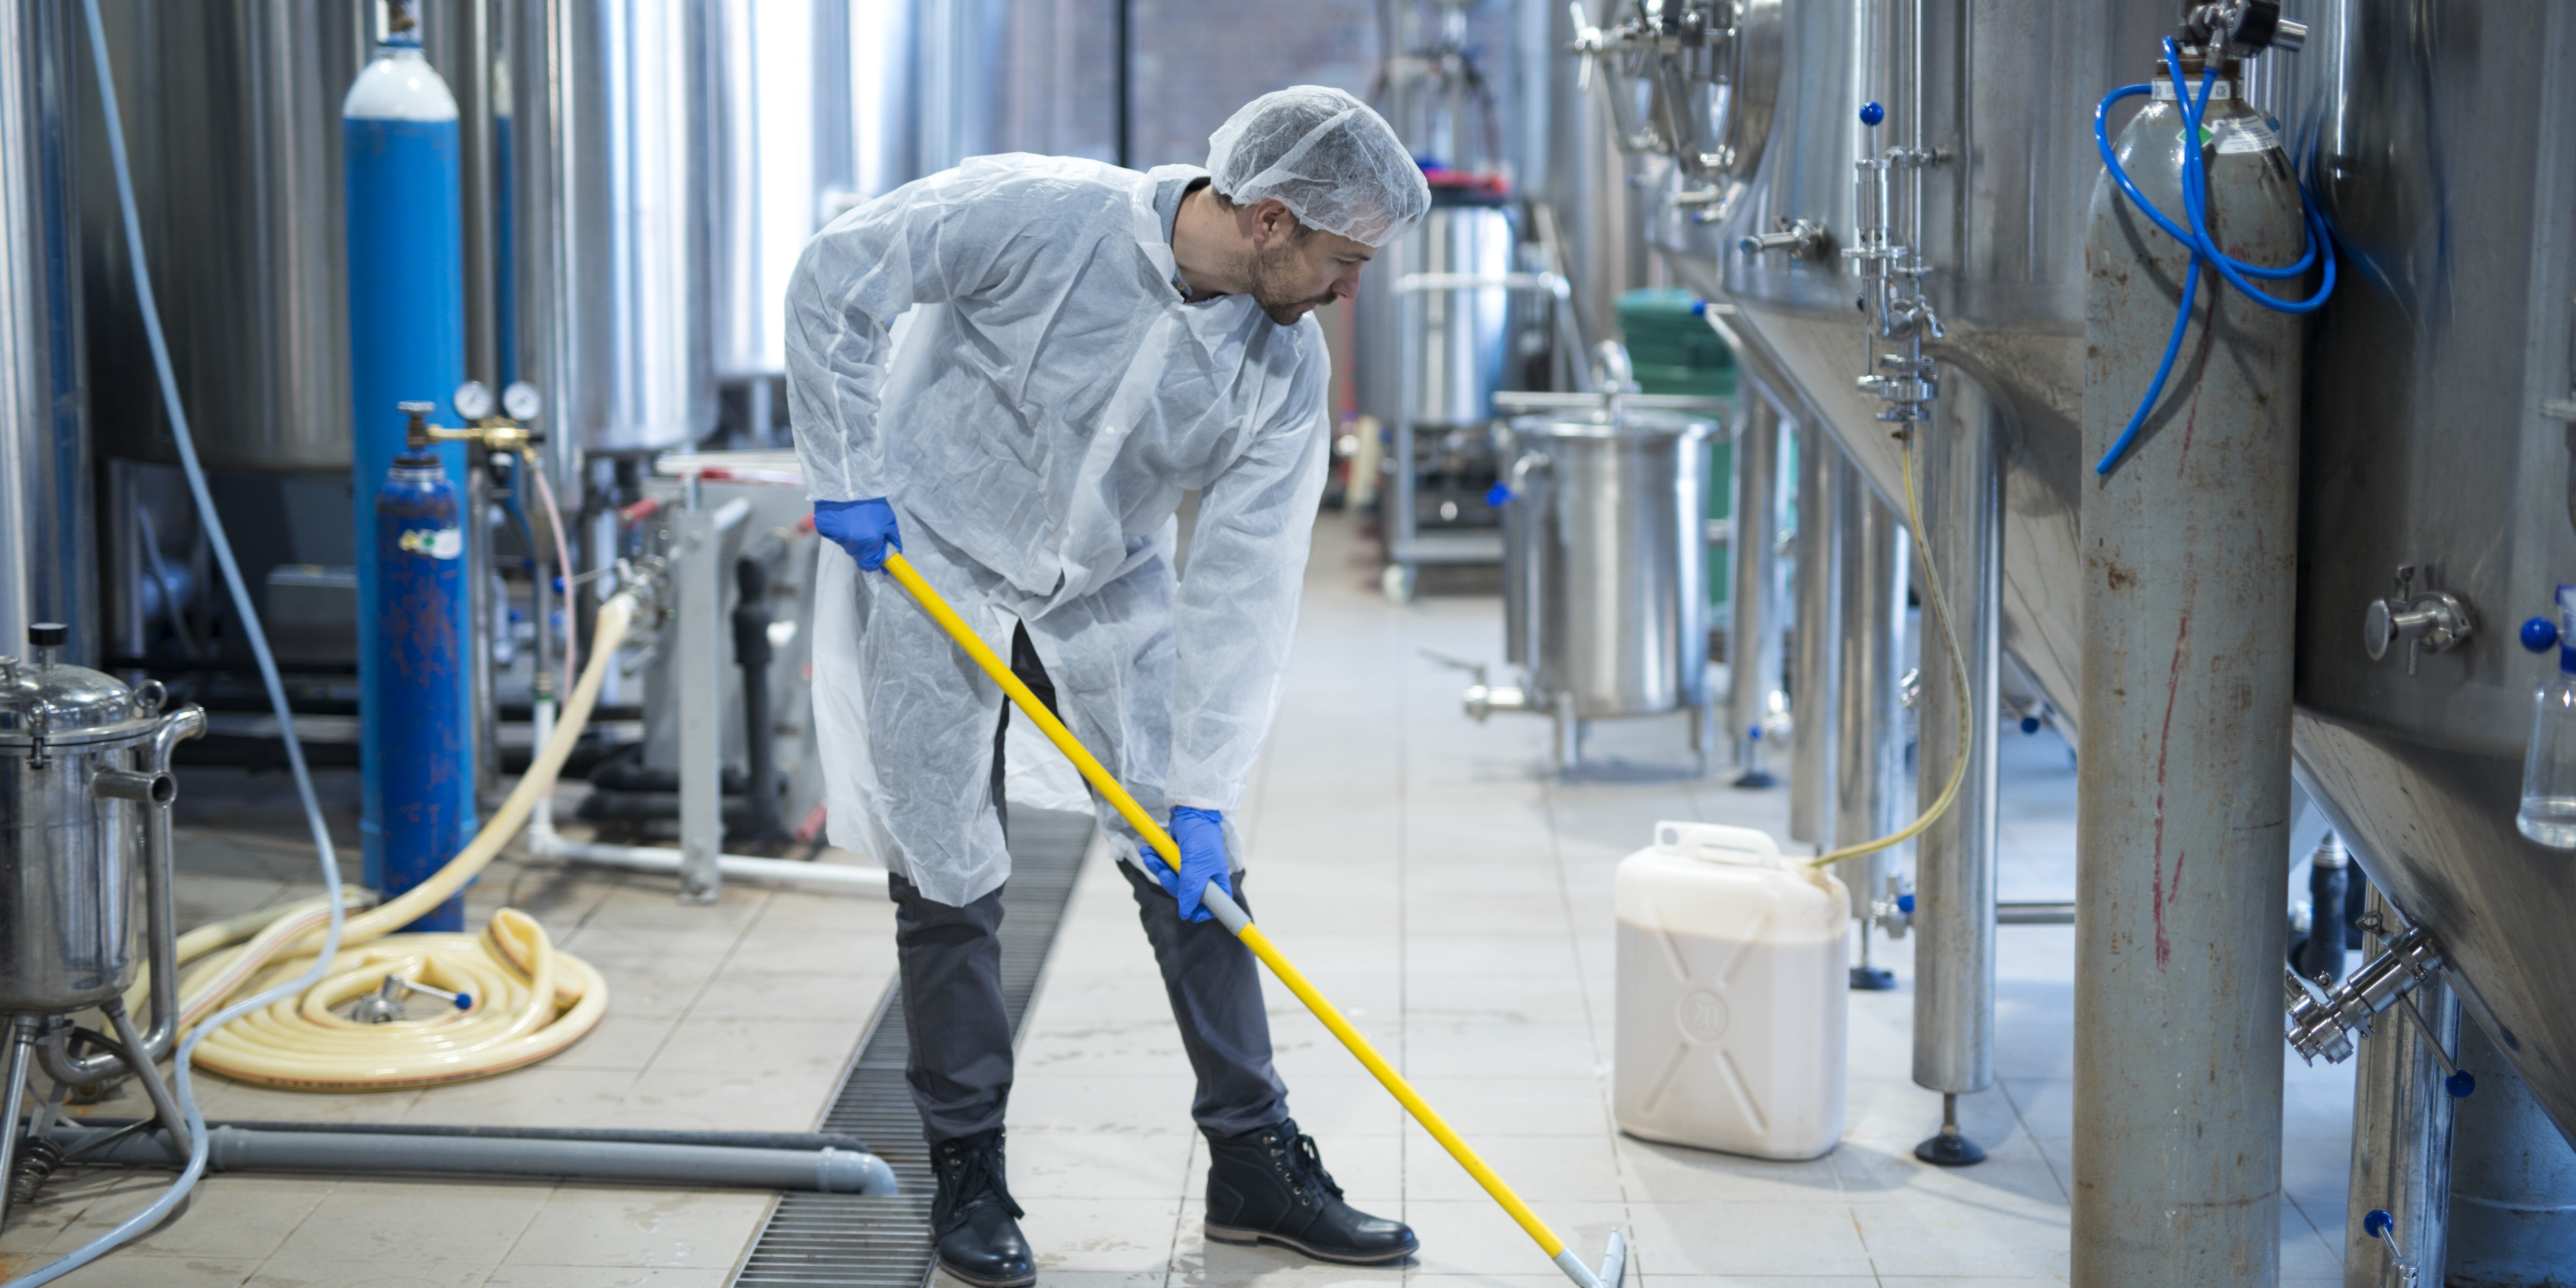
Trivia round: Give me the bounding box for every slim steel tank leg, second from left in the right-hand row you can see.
[1788,417,1849,850]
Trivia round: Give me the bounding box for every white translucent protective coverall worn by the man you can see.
[788,155,1329,904]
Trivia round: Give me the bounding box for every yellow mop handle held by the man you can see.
[886,551,1566,1257]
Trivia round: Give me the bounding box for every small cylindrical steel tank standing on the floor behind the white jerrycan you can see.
[1502,407,1716,768]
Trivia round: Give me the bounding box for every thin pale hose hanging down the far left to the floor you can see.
[0,0,348,1288]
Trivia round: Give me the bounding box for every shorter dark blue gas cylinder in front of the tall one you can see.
[363,453,474,930]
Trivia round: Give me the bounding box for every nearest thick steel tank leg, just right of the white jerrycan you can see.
[1911,379,2009,1167]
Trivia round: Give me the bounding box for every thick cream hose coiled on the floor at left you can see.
[134,590,639,1092]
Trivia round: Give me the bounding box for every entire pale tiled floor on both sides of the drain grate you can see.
[0,507,2352,1288]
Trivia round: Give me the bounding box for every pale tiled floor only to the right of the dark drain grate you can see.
[1010,520,2352,1288]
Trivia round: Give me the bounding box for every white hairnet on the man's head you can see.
[1208,85,1432,245]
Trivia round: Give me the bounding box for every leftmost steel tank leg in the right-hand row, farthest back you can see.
[1726,381,1780,788]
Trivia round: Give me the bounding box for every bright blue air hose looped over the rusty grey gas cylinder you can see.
[2094,36,2334,474]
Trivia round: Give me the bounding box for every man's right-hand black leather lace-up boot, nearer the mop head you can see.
[1208,1118,1422,1265]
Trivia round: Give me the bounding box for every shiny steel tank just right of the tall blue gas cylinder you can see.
[507,0,716,463]
